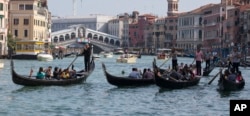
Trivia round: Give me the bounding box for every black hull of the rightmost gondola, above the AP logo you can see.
[218,73,245,91]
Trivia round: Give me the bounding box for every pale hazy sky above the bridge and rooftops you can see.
[48,0,221,17]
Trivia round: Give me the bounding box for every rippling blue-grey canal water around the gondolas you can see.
[0,56,250,116]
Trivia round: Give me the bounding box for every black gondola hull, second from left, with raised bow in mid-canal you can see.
[102,63,154,87]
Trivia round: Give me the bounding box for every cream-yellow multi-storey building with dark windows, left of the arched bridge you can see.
[9,0,50,56]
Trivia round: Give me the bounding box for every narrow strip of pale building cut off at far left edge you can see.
[0,0,9,57]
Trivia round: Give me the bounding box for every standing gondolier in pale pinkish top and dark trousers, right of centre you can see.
[194,46,203,76]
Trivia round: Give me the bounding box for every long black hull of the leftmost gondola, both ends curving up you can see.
[11,58,95,86]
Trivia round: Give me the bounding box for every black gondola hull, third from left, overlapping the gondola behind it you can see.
[153,63,200,89]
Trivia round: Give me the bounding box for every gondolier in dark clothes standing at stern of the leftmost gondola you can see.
[83,44,91,72]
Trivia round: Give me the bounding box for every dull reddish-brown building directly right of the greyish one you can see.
[200,4,225,50]
